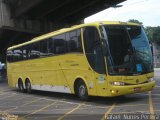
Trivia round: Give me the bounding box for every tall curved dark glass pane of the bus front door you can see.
[83,27,106,74]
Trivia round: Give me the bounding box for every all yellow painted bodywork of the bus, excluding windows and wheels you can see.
[7,22,155,97]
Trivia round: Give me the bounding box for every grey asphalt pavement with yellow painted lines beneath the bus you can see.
[0,70,160,120]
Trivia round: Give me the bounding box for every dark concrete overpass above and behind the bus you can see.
[0,0,125,62]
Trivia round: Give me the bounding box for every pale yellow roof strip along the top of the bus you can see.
[7,21,140,50]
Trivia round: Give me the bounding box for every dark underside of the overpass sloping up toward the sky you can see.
[15,0,125,23]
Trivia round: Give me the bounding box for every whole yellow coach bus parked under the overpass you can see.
[7,21,155,100]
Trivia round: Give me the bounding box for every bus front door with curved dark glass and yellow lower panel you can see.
[83,27,107,96]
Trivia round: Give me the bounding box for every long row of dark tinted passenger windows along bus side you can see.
[7,29,82,62]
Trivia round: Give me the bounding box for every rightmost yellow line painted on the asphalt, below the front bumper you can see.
[148,91,155,120]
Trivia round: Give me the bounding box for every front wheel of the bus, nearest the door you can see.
[76,80,88,100]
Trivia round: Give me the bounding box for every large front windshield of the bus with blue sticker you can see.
[103,25,153,75]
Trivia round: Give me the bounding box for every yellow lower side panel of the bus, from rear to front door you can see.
[8,54,96,95]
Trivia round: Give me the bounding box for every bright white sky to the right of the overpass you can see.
[85,0,160,27]
